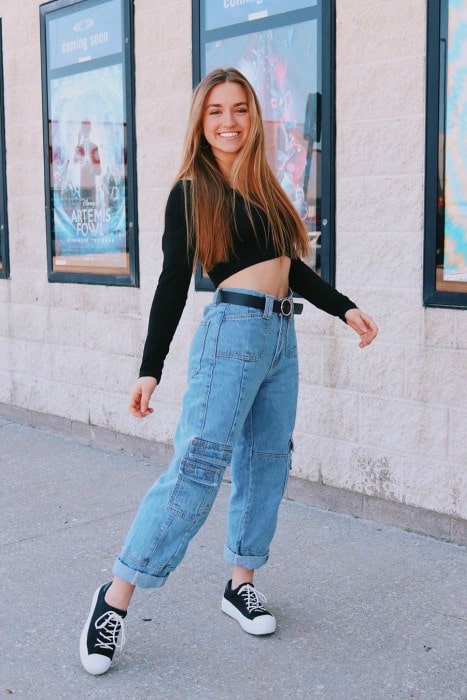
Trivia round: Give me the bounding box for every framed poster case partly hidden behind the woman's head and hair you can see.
[193,0,334,289]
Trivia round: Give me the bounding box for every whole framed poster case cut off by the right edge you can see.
[424,0,467,307]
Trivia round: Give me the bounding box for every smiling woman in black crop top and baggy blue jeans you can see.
[80,68,377,675]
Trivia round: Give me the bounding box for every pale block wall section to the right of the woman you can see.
[304,0,467,518]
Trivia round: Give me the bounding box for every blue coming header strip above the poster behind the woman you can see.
[204,0,318,31]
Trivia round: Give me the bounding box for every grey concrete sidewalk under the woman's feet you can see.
[0,420,467,700]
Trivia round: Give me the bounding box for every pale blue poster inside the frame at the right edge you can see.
[443,0,467,282]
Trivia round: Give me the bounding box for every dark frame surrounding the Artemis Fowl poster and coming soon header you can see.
[39,0,139,287]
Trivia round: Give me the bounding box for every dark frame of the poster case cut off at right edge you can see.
[423,0,467,309]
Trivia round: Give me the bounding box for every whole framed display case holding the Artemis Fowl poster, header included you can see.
[41,0,138,286]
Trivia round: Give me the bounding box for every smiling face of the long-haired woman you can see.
[203,82,251,168]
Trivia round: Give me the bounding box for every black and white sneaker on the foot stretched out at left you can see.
[79,583,126,676]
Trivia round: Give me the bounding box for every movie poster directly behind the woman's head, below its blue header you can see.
[205,20,321,267]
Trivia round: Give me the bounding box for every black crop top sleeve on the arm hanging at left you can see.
[139,183,193,383]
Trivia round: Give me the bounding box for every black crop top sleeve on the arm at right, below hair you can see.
[289,259,357,322]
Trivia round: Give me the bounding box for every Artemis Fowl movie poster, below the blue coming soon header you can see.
[49,64,127,269]
